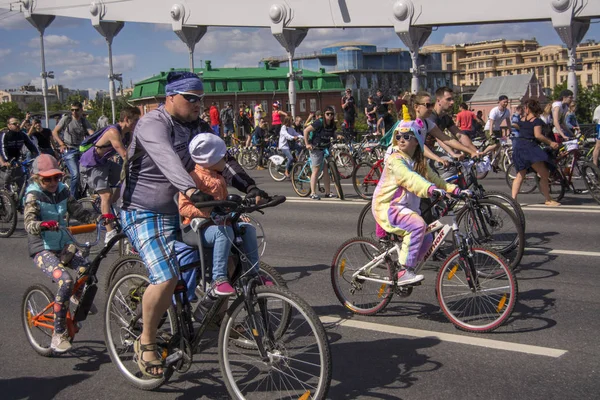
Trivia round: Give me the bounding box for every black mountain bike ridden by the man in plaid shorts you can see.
[104,195,331,399]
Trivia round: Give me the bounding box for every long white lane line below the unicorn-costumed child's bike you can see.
[321,316,567,358]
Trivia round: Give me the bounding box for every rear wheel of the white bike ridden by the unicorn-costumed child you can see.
[331,238,394,315]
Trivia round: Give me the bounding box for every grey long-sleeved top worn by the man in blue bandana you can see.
[122,106,200,214]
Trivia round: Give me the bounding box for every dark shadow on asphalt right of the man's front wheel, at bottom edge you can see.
[328,332,443,400]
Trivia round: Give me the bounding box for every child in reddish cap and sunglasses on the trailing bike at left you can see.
[25,154,115,353]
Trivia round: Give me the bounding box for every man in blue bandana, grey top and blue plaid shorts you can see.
[121,71,267,378]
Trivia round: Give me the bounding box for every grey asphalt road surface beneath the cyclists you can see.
[0,171,600,400]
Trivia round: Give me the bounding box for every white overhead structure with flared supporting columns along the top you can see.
[12,0,600,121]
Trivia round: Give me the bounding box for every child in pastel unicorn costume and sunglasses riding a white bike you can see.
[373,106,460,286]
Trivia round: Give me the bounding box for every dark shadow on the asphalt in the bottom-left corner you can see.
[0,374,92,400]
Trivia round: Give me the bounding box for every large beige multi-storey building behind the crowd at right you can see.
[422,39,600,92]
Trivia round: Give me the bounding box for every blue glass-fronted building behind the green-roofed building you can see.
[261,42,453,104]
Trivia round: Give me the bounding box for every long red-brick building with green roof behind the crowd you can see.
[129,61,344,118]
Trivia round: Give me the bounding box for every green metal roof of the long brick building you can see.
[131,65,344,100]
